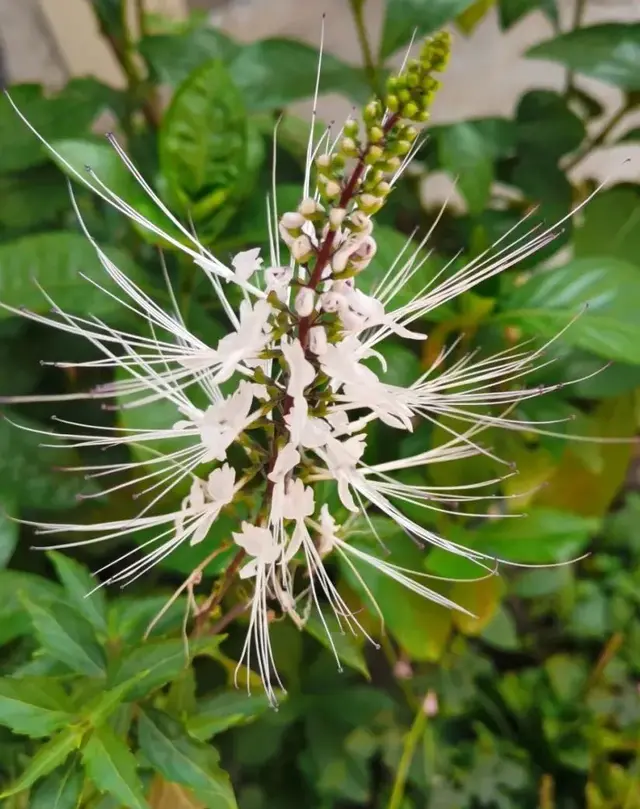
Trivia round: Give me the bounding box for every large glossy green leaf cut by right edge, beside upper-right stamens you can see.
[498,257,640,365]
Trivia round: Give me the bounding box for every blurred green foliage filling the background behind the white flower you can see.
[0,0,640,809]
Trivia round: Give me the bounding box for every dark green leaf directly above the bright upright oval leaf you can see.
[138,28,240,87]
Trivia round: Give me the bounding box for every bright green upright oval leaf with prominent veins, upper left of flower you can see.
[160,62,249,227]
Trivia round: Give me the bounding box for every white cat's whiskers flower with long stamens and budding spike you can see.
[1,35,592,700]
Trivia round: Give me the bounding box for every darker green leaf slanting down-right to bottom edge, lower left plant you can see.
[138,710,237,809]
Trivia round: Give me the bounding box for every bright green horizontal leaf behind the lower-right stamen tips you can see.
[453,508,600,564]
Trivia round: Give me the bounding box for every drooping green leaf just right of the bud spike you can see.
[438,122,493,214]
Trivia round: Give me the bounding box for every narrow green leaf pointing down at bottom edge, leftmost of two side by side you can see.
[82,725,149,809]
